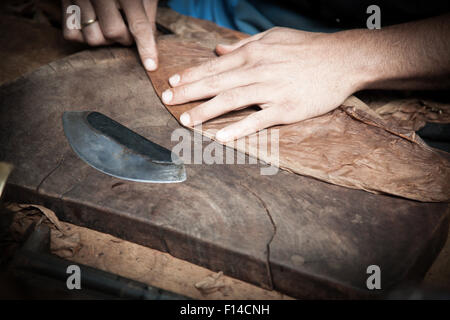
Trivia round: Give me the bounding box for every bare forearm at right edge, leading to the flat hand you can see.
[340,14,450,90]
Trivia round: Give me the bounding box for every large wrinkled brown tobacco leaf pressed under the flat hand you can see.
[148,36,450,202]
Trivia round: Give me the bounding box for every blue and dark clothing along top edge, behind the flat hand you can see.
[167,0,450,34]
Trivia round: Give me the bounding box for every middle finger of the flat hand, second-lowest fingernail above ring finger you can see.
[162,68,260,105]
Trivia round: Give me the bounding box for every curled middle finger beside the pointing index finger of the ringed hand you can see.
[92,0,133,46]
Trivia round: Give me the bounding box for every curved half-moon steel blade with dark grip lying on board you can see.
[63,111,186,183]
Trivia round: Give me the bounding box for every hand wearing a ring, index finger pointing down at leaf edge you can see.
[62,0,158,71]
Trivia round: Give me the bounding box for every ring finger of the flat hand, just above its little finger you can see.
[180,84,264,126]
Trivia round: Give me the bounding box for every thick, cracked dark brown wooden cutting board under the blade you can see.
[0,43,448,298]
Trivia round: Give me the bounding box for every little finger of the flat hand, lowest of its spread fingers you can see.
[216,107,280,142]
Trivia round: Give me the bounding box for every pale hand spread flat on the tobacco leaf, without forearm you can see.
[162,28,361,142]
